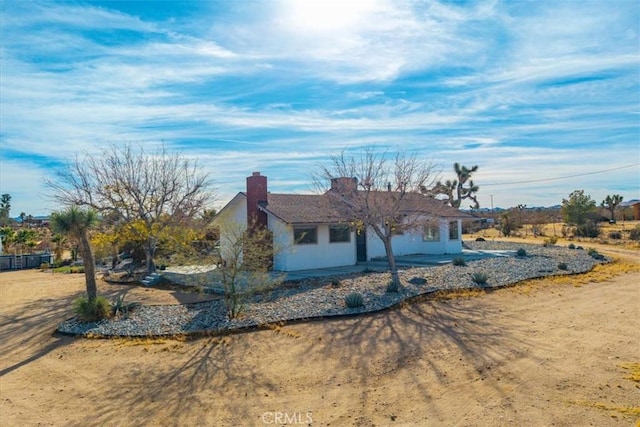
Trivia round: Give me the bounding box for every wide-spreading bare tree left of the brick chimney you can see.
[45,144,213,273]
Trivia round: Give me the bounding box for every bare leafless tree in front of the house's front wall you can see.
[314,148,440,286]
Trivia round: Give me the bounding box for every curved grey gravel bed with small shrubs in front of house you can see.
[57,241,607,337]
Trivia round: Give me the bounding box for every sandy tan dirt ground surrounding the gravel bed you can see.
[0,242,640,426]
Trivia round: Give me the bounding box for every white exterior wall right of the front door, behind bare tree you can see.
[367,220,462,260]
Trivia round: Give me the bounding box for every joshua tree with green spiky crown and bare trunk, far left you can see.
[51,206,98,301]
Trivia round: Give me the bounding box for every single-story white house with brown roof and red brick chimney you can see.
[215,172,474,271]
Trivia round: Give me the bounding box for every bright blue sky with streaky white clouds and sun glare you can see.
[0,0,640,215]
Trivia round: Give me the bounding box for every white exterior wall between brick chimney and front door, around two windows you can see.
[269,221,356,271]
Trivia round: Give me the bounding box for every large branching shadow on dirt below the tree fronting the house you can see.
[301,300,544,425]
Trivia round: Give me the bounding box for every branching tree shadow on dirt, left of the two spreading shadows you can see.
[79,335,275,425]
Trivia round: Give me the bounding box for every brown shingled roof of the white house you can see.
[261,190,475,224]
